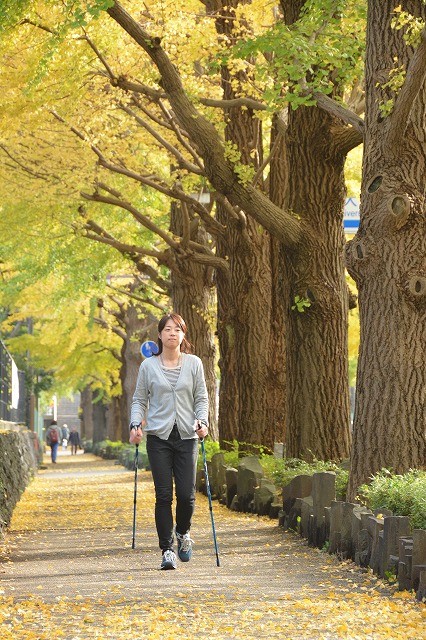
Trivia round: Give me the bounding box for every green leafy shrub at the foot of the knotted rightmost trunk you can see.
[358,469,426,529]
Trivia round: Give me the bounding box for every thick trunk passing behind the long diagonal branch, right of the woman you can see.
[210,0,284,449]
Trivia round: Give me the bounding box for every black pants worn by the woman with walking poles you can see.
[146,426,198,551]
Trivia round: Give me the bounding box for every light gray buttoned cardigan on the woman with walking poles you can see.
[130,353,208,440]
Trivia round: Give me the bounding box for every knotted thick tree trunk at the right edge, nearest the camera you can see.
[347,0,426,500]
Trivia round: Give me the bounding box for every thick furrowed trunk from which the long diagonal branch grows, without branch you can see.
[283,107,350,460]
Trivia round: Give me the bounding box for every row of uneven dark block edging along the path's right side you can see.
[197,452,426,600]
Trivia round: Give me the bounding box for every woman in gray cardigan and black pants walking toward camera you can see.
[130,313,208,569]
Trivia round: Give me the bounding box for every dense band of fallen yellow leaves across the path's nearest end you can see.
[0,593,426,640]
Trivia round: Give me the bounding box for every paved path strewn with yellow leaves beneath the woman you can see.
[0,454,426,640]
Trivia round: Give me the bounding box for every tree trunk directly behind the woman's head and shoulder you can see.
[170,203,219,440]
